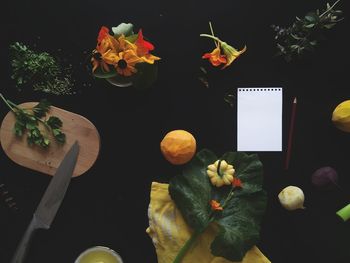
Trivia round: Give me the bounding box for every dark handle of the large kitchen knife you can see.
[11,215,41,263]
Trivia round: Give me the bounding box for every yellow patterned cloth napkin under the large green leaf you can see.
[146,182,271,263]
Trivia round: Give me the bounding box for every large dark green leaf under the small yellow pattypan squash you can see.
[169,150,267,261]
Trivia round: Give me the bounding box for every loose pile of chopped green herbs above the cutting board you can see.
[10,42,74,95]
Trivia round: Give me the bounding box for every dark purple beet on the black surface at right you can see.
[311,166,338,188]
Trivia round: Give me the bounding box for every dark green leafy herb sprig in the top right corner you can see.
[271,0,343,62]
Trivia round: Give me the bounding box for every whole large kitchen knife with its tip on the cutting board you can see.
[11,141,79,263]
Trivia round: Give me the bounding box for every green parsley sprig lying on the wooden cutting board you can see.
[0,93,66,148]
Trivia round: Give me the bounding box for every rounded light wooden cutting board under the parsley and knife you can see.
[0,102,100,177]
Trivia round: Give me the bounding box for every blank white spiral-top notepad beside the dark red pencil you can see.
[237,87,283,152]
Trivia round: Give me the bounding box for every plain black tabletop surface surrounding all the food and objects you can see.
[0,0,350,263]
